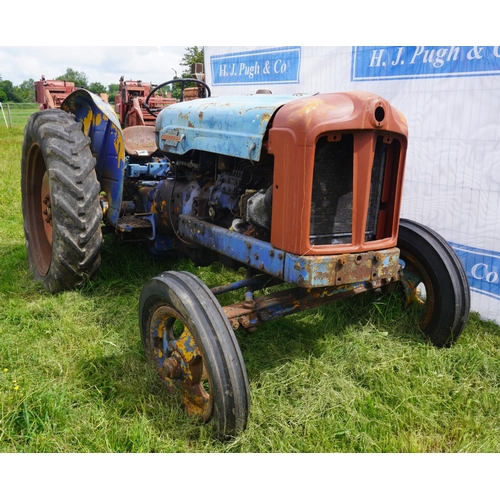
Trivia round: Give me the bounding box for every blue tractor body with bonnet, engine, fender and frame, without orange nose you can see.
[59,89,399,292]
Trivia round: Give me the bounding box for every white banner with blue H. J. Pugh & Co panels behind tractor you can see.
[205,46,500,323]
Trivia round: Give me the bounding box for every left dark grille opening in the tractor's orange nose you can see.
[310,134,354,245]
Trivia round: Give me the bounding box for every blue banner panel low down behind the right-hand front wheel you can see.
[450,242,500,300]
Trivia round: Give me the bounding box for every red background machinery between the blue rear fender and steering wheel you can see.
[115,76,177,128]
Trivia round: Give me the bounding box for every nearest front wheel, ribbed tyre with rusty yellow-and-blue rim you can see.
[139,271,250,438]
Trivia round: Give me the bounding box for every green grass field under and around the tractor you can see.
[0,109,500,453]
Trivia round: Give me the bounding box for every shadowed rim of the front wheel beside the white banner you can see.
[400,254,435,331]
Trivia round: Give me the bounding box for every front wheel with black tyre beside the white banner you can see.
[398,219,470,347]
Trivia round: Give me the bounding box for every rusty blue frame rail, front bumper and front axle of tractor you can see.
[179,215,401,331]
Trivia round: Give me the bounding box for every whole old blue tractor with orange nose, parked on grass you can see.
[21,80,470,437]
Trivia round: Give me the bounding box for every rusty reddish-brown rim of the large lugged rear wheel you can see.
[26,145,52,276]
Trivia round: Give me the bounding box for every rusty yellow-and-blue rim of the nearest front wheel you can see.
[149,305,213,422]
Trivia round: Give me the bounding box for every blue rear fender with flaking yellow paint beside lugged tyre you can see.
[61,89,125,226]
